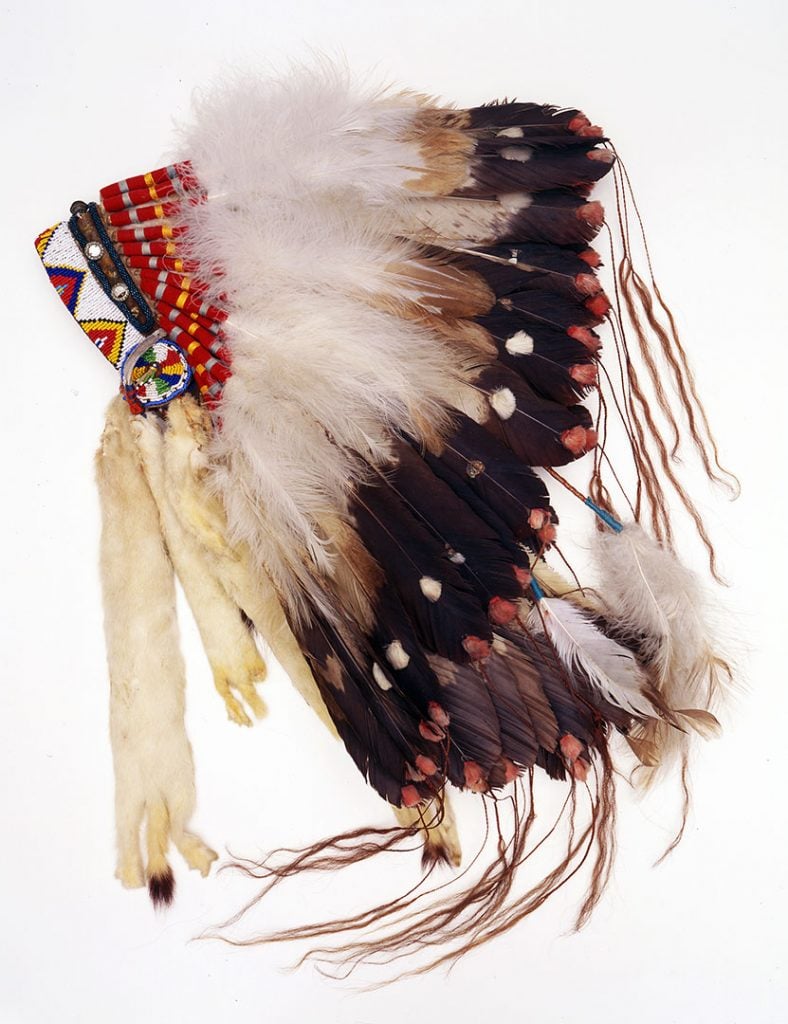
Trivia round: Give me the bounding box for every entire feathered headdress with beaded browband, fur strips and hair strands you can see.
[37,67,726,966]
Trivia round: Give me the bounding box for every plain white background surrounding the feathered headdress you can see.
[0,0,788,1024]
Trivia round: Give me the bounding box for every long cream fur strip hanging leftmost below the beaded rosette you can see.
[96,399,216,886]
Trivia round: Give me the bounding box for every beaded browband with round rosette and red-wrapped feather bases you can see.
[36,163,230,413]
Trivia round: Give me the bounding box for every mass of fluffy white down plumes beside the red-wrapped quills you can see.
[176,68,472,611]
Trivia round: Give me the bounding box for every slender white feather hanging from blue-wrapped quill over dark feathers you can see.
[528,597,656,718]
